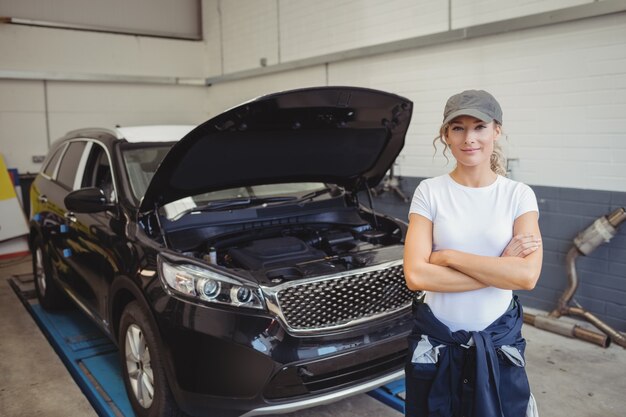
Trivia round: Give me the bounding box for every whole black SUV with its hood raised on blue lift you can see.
[30,87,414,416]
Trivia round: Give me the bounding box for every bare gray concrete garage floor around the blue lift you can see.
[0,257,626,417]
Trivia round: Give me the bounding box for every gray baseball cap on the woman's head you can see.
[442,90,502,125]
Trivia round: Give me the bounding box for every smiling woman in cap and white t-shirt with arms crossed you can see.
[404,90,542,417]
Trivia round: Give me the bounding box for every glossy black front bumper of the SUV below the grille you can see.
[148,286,412,417]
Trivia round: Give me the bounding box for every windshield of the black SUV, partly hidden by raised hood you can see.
[122,144,327,214]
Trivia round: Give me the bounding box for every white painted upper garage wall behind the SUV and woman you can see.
[0,0,626,191]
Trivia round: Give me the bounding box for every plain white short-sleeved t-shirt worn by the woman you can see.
[409,174,539,331]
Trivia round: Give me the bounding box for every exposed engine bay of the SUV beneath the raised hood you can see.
[186,220,403,284]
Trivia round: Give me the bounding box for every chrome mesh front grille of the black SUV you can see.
[277,263,414,332]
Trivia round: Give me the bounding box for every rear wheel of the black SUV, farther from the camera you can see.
[33,237,68,310]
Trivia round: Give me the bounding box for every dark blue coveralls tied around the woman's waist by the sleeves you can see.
[405,297,530,417]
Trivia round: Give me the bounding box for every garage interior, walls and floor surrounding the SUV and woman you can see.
[0,0,626,417]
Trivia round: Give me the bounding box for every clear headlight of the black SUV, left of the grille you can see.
[159,257,265,310]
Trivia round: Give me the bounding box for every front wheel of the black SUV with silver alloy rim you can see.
[118,301,185,417]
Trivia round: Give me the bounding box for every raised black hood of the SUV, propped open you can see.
[140,87,413,211]
